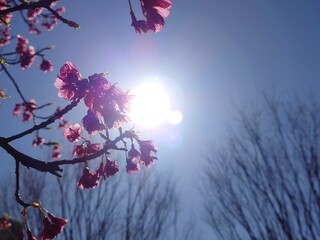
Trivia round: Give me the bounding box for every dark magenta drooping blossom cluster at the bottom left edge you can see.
[19,205,68,240]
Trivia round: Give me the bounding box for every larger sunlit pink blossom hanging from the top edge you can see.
[140,0,172,32]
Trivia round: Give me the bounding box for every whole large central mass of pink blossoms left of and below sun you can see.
[55,62,157,189]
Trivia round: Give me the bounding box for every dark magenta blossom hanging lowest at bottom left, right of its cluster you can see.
[40,213,68,240]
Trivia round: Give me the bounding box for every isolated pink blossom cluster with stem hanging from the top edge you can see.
[129,0,172,34]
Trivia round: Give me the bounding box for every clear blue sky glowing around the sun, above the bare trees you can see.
[0,0,320,239]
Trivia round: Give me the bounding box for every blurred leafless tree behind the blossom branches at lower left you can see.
[0,162,185,240]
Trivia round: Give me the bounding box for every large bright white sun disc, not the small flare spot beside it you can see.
[129,81,170,128]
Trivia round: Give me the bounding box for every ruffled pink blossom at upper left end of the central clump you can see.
[54,62,87,100]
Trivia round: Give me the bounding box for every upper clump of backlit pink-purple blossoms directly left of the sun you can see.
[55,62,132,130]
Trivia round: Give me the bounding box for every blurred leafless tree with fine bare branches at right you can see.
[200,97,320,239]
